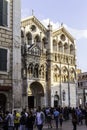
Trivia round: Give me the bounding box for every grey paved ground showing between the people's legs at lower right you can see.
[34,120,87,130]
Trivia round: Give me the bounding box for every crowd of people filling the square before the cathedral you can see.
[0,106,87,130]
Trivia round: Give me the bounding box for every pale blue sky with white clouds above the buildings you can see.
[21,0,87,72]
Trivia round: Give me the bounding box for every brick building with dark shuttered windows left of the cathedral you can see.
[0,0,22,111]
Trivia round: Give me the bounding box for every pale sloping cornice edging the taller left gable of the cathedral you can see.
[21,16,47,33]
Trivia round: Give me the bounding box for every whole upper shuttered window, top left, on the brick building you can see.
[0,0,8,26]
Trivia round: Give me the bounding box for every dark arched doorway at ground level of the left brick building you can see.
[0,93,6,113]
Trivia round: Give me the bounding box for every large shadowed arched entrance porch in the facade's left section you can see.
[28,82,44,107]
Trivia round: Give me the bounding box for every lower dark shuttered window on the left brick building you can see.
[0,48,7,71]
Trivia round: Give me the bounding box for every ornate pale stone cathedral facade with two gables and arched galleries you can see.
[21,16,76,107]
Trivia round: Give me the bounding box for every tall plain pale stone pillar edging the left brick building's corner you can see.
[12,0,22,109]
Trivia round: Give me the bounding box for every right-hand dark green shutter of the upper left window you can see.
[3,0,8,26]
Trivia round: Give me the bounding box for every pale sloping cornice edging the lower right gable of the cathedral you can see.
[53,26,75,41]
